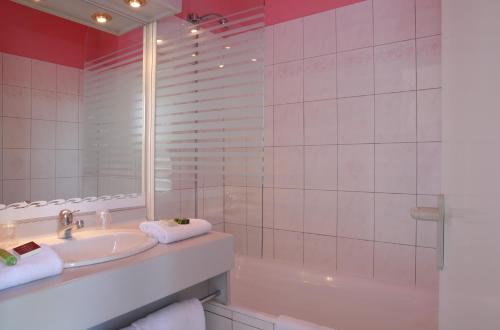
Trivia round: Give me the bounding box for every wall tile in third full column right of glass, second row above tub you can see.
[338,191,374,240]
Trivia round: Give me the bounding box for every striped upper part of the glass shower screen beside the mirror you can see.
[155,7,264,195]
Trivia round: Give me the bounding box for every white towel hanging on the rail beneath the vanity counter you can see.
[130,299,205,330]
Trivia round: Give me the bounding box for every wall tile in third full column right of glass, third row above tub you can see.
[338,144,374,192]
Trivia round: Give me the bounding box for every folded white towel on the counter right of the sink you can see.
[139,219,212,244]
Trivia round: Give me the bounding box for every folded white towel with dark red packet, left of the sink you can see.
[0,245,63,290]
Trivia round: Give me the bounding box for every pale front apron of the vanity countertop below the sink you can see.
[0,227,234,329]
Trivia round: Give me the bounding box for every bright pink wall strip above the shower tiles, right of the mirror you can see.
[179,0,361,25]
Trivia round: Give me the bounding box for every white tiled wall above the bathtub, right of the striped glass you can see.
[224,0,441,288]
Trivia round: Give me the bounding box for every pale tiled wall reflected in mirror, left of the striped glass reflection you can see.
[0,53,84,204]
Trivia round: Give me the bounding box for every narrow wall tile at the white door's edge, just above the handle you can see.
[417,142,441,195]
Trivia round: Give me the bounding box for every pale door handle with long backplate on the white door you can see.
[410,195,444,270]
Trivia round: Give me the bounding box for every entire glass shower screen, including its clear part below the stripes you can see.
[154,1,264,256]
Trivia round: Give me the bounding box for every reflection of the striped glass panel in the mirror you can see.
[79,40,144,196]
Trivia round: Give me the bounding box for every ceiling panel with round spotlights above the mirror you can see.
[13,0,182,35]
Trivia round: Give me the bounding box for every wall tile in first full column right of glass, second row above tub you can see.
[274,189,304,232]
